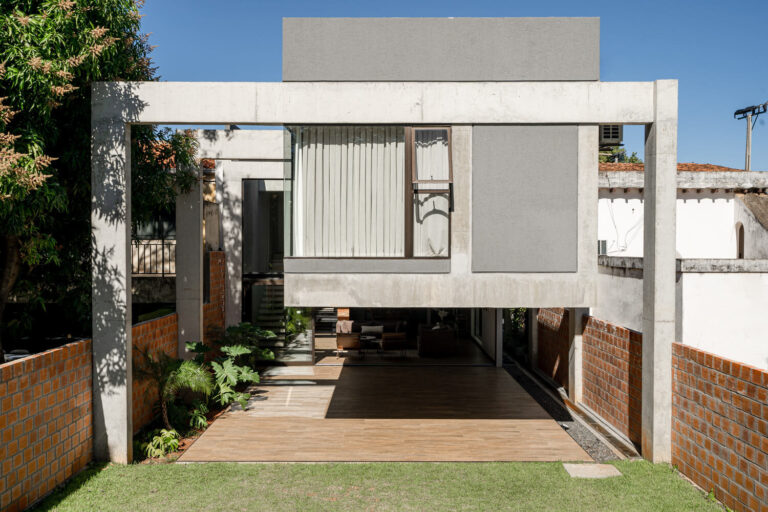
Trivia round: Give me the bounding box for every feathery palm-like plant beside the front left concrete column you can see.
[134,348,214,430]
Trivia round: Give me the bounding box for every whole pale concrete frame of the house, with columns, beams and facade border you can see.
[91,19,677,462]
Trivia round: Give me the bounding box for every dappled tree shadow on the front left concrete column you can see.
[91,82,147,458]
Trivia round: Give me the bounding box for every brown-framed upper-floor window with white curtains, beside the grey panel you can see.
[285,126,453,258]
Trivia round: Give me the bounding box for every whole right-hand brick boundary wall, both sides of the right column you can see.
[582,317,768,512]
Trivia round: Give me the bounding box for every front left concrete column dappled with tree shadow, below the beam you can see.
[91,118,133,464]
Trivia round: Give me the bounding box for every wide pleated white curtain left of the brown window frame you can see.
[293,126,405,257]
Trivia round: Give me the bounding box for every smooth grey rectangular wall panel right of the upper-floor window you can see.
[472,126,578,272]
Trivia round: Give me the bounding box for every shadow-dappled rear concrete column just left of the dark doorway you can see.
[216,160,243,327]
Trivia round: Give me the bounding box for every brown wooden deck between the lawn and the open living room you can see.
[179,366,591,462]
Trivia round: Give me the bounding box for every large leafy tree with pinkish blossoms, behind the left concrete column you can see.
[0,0,195,355]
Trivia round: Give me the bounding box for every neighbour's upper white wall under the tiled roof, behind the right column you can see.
[597,189,736,258]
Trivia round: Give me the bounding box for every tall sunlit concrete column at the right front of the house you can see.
[641,80,677,462]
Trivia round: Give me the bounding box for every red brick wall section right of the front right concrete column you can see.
[672,343,768,512]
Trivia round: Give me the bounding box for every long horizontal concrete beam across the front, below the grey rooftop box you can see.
[92,82,654,125]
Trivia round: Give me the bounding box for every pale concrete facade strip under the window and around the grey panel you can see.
[285,125,598,308]
